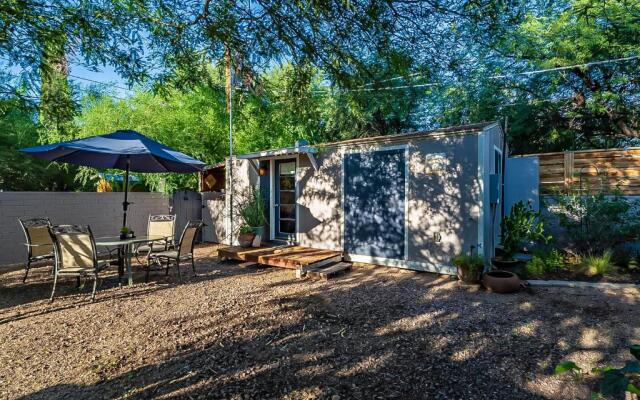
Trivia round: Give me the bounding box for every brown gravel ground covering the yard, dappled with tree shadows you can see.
[0,246,640,400]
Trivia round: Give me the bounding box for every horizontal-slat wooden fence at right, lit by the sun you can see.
[536,147,640,196]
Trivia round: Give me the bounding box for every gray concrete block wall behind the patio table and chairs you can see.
[0,192,169,266]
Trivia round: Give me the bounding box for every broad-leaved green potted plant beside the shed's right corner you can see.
[500,201,551,258]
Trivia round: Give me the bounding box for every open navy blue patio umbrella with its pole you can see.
[20,130,205,226]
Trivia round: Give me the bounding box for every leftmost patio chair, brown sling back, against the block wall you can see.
[18,217,54,283]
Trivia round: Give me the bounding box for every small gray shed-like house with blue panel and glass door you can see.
[220,123,504,274]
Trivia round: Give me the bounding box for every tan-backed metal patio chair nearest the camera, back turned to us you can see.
[49,225,109,301]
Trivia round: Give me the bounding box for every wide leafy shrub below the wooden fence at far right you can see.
[553,193,640,255]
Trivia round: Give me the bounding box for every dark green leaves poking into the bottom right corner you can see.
[555,344,640,399]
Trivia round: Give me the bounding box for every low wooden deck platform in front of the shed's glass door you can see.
[218,246,342,271]
